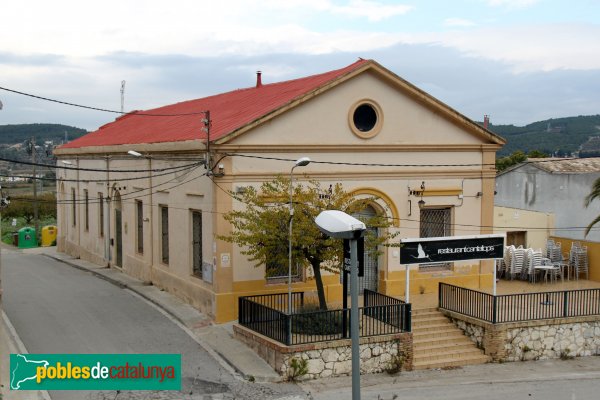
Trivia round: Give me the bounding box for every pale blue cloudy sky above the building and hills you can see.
[0,0,600,130]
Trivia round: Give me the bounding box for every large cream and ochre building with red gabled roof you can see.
[56,59,504,322]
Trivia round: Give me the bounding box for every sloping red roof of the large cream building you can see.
[61,59,371,149]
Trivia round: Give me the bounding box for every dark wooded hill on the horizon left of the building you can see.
[0,124,87,145]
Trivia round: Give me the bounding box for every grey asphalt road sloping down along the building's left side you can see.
[2,249,297,400]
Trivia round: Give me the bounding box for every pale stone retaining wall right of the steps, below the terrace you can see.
[440,310,600,361]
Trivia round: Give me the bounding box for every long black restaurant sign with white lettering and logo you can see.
[400,234,505,264]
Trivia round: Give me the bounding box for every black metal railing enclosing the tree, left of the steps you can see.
[238,290,411,346]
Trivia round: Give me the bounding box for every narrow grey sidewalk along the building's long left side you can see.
[9,247,281,382]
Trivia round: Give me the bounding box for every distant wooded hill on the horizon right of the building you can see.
[489,115,600,157]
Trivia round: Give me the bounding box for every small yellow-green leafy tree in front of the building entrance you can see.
[219,177,398,310]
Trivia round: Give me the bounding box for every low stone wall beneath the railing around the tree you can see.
[233,325,413,379]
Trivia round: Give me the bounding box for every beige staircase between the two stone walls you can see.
[412,308,489,369]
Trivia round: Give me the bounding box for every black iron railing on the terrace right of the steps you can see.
[439,282,600,324]
